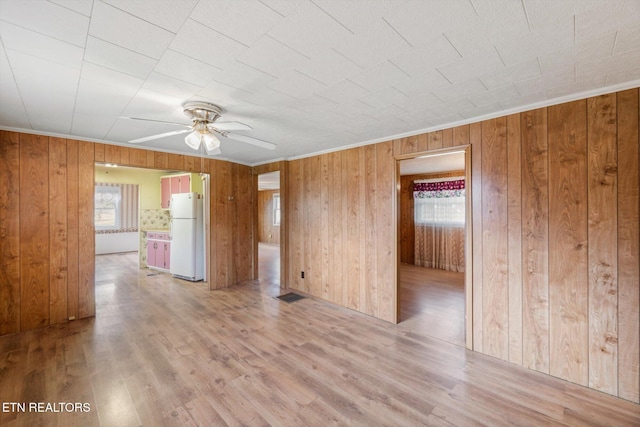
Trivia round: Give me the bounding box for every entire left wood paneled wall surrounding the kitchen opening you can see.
[0,135,254,335]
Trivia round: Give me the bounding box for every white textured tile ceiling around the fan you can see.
[0,0,640,164]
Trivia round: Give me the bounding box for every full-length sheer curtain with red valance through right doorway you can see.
[413,177,465,272]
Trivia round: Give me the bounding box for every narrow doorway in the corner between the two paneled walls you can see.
[257,171,283,296]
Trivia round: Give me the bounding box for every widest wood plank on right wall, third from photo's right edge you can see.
[548,101,589,385]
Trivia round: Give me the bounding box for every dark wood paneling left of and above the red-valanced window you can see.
[398,170,465,264]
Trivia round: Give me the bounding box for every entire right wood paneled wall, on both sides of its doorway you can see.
[286,89,640,402]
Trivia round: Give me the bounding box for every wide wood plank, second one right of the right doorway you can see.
[482,117,509,360]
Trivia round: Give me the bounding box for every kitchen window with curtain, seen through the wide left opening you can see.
[94,183,138,233]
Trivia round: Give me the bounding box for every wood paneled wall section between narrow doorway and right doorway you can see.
[283,142,397,322]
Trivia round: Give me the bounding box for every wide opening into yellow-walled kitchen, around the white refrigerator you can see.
[95,163,210,286]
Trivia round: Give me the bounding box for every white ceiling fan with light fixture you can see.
[122,101,276,155]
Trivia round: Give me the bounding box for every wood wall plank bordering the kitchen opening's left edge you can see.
[78,141,96,319]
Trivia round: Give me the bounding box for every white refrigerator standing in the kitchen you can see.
[169,193,204,282]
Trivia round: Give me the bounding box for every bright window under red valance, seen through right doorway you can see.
[413,178,465,227]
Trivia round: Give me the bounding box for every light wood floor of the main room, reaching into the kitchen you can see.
[0,249,640,426]
